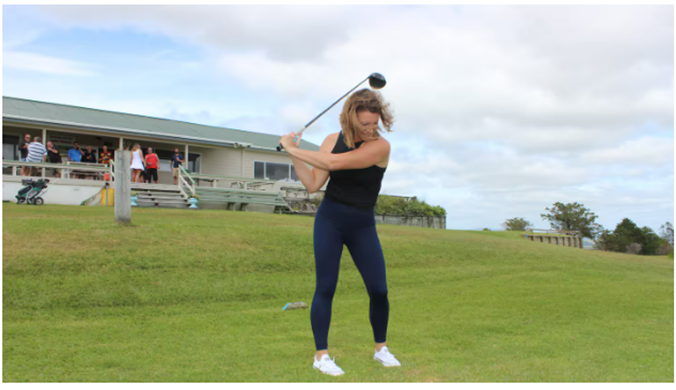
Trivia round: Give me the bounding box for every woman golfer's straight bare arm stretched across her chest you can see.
[282,133,390,171]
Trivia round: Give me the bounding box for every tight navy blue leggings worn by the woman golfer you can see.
[310,198,390,351]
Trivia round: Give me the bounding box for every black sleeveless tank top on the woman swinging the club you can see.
[326,131,386,207]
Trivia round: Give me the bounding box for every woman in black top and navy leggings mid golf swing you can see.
[280,89,401,376]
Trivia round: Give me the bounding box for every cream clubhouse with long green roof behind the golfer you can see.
[2,96,319,209]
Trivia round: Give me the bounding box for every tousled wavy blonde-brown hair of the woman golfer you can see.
[340,88,394,149]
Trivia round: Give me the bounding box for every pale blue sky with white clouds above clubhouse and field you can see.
[3,6,674,231]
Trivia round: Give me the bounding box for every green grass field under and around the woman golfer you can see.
[3,204,674,382]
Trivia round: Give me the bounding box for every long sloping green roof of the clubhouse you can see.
[2,96,319,151]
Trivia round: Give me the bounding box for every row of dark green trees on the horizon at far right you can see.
[500,202,674,258]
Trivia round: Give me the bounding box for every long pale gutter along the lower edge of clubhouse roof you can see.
[3,114,277,151]
